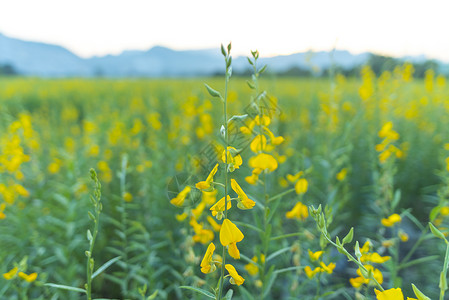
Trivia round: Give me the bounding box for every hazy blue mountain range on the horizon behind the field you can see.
[0,33,440,77]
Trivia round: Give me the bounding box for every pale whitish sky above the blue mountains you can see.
[0,0,449,62]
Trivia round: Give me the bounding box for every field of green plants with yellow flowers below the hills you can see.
[0,49,449,299]
